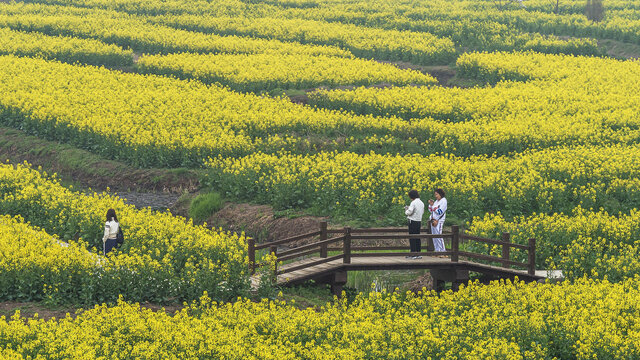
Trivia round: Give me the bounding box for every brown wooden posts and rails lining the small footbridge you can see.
[247,221,536,275]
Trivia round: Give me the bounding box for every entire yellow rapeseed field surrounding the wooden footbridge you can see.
[0,0,640,359]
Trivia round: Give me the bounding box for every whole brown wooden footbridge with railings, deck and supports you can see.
[248,222,545,295]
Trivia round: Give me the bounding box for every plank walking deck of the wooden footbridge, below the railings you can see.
[268,256,544,285]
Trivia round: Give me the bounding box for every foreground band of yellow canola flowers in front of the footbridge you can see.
[0,278,640,360]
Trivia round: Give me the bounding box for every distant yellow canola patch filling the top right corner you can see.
[281,0,640,55]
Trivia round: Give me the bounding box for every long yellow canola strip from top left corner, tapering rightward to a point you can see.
[0,3,353,57]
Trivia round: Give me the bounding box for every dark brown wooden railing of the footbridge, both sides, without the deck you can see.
[247,222,536,275]
